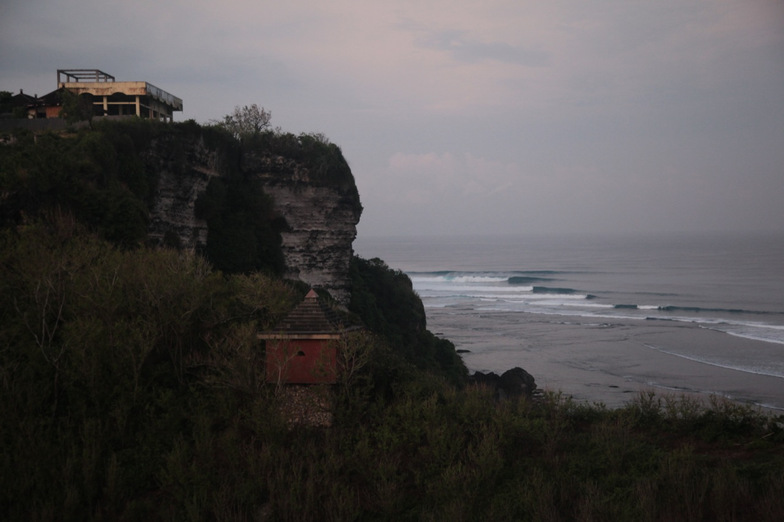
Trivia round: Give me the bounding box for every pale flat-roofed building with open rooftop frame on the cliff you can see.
[57,69,182,121]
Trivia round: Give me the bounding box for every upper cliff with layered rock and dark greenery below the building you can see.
[0,119,362,303]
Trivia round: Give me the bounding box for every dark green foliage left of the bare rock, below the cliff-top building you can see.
[0,124,155,246]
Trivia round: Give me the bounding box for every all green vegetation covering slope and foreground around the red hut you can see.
[0,122,784,521]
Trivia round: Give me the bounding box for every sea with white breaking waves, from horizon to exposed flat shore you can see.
[354,234,784,402]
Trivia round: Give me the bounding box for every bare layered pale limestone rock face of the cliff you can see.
[145,131,362,304]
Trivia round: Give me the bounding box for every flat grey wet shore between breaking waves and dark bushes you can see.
[427,308,784,410]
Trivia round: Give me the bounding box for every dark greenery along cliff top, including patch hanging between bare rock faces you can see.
[0,118,285,268]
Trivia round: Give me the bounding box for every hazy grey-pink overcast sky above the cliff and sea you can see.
[0,0,784,236]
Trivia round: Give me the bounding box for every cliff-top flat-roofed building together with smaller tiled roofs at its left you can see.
[5,69,182,121]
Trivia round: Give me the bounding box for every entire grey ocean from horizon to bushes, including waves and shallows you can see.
[354,234,784,409]
